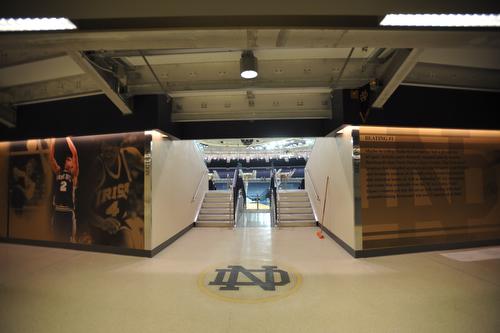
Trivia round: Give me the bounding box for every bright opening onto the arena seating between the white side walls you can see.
[197,138,315,228]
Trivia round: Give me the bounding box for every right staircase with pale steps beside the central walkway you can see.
[277,190,316,227]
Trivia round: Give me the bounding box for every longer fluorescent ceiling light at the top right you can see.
[380,14,500,27]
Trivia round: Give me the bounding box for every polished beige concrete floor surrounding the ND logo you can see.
[0,228,500,333]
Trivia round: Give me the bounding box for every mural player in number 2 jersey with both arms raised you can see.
[50,137,79,243]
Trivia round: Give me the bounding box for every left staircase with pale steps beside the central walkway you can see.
[196,191,234,227]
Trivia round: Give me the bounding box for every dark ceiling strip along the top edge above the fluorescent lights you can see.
[0,0,500,21]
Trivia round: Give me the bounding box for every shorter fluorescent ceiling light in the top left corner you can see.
[0,17,76,31]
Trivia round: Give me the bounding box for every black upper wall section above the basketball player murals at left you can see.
[0,95,176,140]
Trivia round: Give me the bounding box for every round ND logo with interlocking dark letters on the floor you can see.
[198,262,302,303]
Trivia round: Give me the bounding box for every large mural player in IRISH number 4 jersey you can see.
[90,138,144,248]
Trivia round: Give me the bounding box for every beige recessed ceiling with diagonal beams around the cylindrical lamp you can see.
[0,1,500,128]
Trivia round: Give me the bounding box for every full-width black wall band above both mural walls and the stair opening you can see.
[0,86,500,140]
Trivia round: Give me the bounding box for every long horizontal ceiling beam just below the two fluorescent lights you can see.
[0,28,500,52]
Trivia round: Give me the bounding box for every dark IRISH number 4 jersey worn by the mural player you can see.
[95,152,131,225]
